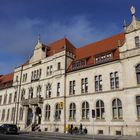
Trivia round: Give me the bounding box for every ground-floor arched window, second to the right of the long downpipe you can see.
[82,101,89,119]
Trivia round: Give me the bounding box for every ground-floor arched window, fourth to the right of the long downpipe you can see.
[112,99,123,119]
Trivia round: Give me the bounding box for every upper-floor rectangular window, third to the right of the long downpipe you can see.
[95,75,102,91]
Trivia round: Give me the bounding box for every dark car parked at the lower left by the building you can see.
[0,124,18,134]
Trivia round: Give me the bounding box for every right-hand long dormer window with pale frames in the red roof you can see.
[95,53,112,64]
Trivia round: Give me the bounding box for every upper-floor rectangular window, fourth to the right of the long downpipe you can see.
[110,72,119,89]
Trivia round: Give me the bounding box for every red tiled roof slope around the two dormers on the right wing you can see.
[68,33,125,71]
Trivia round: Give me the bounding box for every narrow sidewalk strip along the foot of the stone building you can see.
[20,132,140,140]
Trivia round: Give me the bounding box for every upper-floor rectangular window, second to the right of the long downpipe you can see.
[81,78,88,93]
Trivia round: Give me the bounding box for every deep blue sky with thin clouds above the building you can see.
[0,0,140,74]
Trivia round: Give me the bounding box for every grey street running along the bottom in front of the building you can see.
[0,133,140,140]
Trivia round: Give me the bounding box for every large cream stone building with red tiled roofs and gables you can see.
[0,6,140,135]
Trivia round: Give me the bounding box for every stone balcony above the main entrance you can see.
[21,97,43,106]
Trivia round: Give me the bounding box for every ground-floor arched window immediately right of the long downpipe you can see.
[69,103,76,120]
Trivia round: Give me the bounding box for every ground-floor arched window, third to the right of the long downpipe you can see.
[96,100,105,119]
